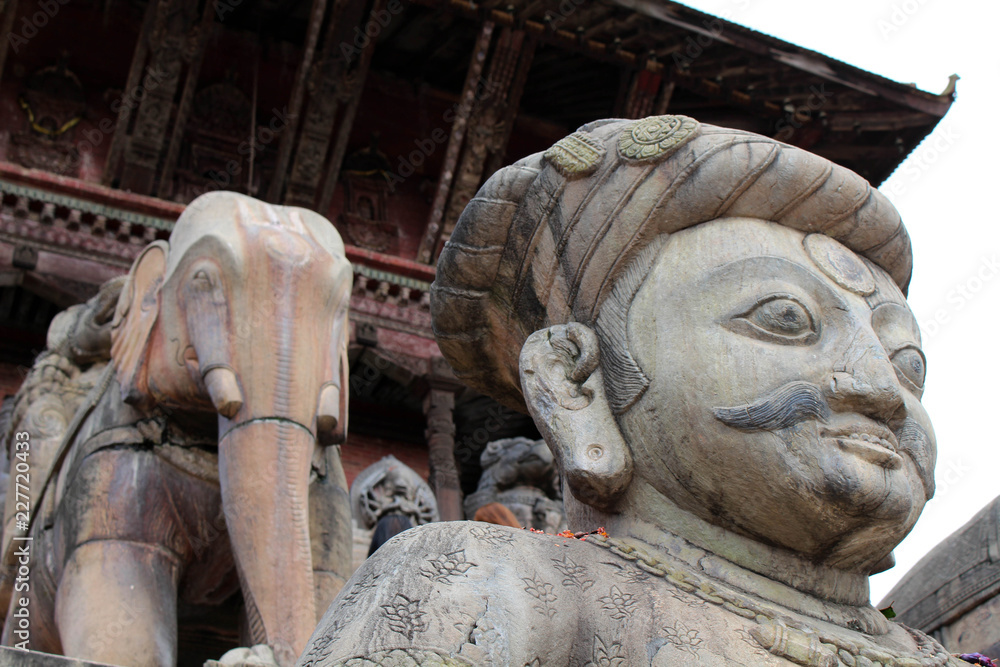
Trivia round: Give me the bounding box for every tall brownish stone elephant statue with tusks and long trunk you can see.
[0,192,353,665]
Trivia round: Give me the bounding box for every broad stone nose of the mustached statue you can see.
[826,330,904,422]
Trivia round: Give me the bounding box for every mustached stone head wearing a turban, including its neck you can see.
[432,116,935,575]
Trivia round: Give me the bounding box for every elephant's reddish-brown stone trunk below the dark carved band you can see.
[219,417,316,666]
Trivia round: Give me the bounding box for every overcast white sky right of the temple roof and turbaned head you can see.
[682,0,1000,604]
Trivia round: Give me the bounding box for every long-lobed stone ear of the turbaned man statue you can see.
[521,322,632,510]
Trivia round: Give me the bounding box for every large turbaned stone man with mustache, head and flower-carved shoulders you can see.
[299,116,965,667]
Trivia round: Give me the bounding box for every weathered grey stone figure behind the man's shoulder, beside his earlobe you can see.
[465,438,566,534]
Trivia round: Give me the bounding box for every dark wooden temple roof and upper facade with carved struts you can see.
[0,0,954,362]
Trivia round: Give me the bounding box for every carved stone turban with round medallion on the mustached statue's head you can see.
[431,116,911,410]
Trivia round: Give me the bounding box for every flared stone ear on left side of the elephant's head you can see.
[111,241,170,404]
